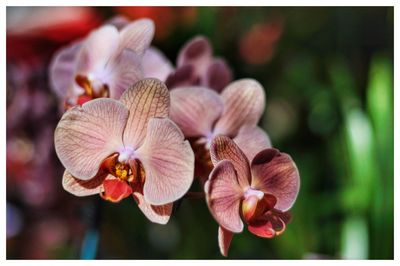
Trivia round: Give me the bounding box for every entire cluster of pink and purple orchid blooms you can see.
[50,18,300,256]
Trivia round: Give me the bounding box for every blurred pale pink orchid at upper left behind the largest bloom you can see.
[50,19,154,109]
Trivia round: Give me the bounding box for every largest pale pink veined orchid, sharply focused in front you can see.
[54,79,194,224]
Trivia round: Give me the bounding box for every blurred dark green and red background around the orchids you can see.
[6,7,394,259]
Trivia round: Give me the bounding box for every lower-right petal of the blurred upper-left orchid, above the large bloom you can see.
[104,50,143,99]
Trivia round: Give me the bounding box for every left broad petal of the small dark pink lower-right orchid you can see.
[204,160,243,233]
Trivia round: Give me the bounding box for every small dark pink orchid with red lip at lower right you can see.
[205,135,300,256]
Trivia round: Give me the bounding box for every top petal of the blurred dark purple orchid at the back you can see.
[176,36,212,76]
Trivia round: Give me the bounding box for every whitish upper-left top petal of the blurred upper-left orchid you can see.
[77,25,119,75]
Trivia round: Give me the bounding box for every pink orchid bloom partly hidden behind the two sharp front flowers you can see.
[170,79,271,179]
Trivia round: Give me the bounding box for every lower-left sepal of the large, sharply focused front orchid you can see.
[62,171,107,197]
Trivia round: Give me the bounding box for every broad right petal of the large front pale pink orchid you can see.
[136,118,194,205]
